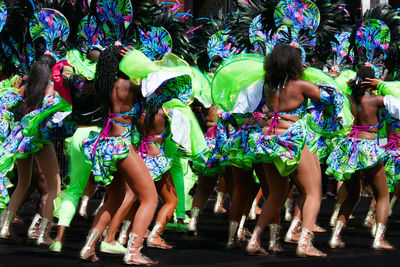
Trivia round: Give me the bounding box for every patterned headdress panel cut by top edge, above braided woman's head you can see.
[96,0,133,45]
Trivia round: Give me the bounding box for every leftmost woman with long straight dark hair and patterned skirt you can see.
[0,55,67,245]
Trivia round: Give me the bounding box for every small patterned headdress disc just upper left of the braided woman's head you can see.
[77,16,104,46]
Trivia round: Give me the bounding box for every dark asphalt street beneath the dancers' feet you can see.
[0,194,400,267]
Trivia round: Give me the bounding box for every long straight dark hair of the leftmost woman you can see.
[23,55,56,114]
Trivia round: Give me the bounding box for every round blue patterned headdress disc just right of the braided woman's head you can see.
[139,26,172,61]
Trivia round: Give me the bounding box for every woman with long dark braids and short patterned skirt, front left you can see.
[80,46,158,265]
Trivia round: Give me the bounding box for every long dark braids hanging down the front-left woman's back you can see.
[94,46,122,126]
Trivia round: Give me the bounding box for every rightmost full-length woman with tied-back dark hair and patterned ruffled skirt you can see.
[327,67,393,250]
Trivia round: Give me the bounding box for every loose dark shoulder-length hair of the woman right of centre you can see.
[264,45,303,90]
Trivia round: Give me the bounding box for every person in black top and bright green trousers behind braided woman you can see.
[49,49,101,252]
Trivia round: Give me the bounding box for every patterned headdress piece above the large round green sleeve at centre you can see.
[207,28,239,59]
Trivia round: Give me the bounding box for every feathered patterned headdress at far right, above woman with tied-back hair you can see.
[351,5,400,77]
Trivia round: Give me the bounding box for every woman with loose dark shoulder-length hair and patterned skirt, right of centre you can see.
[246,45,342,257]
